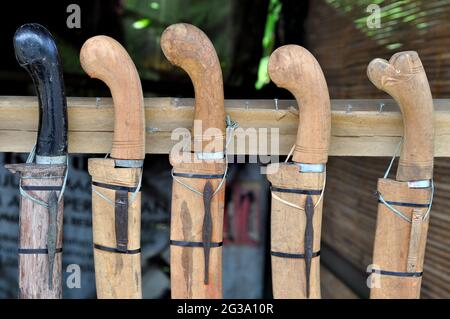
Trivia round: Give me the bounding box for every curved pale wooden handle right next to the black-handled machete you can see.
[80,36,145,160]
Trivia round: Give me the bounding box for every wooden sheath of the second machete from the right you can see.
[267,163,325,299]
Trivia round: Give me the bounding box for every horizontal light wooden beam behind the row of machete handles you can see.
[0,96,450,157]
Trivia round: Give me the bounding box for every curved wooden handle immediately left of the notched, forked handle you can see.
[269,45,331,164]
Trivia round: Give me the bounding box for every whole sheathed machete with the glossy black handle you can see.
[6,24,67,299]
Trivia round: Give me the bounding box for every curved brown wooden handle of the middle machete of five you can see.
[161,23,225,151]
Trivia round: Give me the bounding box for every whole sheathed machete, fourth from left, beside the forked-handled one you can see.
[268,45,331,299]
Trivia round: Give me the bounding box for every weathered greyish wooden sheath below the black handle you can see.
[5,164,66,299]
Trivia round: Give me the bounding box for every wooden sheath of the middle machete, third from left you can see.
[170,153,225,299]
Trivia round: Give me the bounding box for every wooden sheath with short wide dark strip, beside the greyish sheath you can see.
[88,158,142,299]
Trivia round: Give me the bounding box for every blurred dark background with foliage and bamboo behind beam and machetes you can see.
[0,0,450,298]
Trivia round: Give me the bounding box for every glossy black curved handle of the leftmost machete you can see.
[14,23,67,157]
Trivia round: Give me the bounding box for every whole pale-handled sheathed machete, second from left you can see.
[80,36,145,299]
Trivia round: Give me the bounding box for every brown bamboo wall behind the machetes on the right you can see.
[307,0,450,298]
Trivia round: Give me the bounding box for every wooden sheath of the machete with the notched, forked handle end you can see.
[370,179,431,299]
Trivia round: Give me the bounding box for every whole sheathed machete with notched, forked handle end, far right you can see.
[367,51,434,299]
